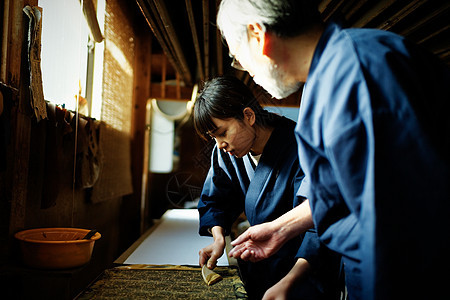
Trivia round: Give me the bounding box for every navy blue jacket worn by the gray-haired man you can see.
[296,23,450,300]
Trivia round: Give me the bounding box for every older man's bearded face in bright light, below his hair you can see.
[230,35,301,99]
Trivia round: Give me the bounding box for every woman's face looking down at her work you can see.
[209,118,256,157]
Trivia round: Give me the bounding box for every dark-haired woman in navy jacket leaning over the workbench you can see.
[194,77,340,299]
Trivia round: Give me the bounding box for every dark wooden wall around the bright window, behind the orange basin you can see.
[0,0,152,299]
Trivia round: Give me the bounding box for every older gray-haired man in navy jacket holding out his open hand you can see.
[217,0,450,300]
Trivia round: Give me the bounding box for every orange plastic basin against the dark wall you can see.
[14,228,101,269]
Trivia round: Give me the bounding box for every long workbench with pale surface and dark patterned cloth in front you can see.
[77,209,247,300]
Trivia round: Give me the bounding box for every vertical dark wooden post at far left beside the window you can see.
[2,0,37,235]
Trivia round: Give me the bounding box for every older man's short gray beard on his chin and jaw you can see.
[253,64,301,99]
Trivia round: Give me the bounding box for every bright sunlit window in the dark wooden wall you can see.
[39,0,105,119]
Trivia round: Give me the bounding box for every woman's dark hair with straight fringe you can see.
[194,76,277,139]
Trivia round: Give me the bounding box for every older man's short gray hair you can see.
[217,0,320,43]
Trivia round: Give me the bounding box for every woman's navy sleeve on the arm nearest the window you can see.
[198,147,244,236]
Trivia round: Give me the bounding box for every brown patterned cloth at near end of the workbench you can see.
[77,266,247,300]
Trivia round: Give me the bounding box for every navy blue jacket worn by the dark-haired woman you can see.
[198,116,337,299]
